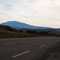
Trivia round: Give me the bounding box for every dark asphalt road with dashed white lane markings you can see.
[0,37,60,60]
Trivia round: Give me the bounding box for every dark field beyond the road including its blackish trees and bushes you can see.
[0,25,60,38]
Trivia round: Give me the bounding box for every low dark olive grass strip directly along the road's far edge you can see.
[0,32,58,38]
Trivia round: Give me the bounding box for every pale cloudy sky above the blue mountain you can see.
[0,0,60,28]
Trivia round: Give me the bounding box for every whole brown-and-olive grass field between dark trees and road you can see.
[0,30,59,38]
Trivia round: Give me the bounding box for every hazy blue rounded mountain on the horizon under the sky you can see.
[1,21,48,29]
